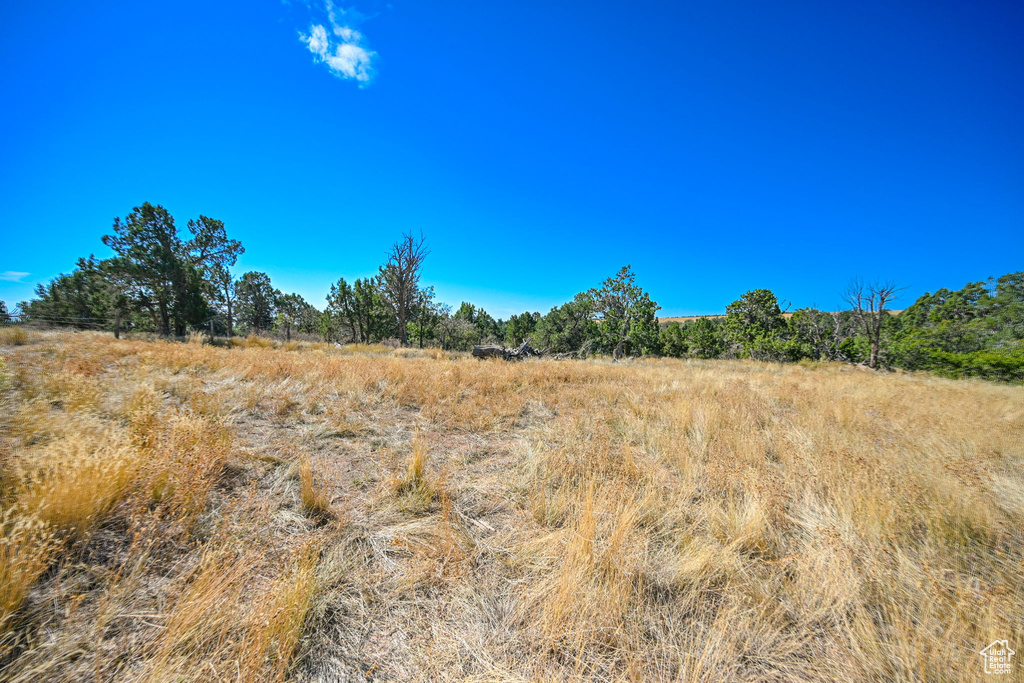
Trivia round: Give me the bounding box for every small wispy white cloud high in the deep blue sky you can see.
[299,0,377,87]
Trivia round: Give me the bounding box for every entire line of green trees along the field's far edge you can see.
[9,203,1024,381]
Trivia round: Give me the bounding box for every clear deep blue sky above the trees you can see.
[0,0,1024,316]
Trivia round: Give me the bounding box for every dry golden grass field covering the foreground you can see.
[0,329,1024,681]
